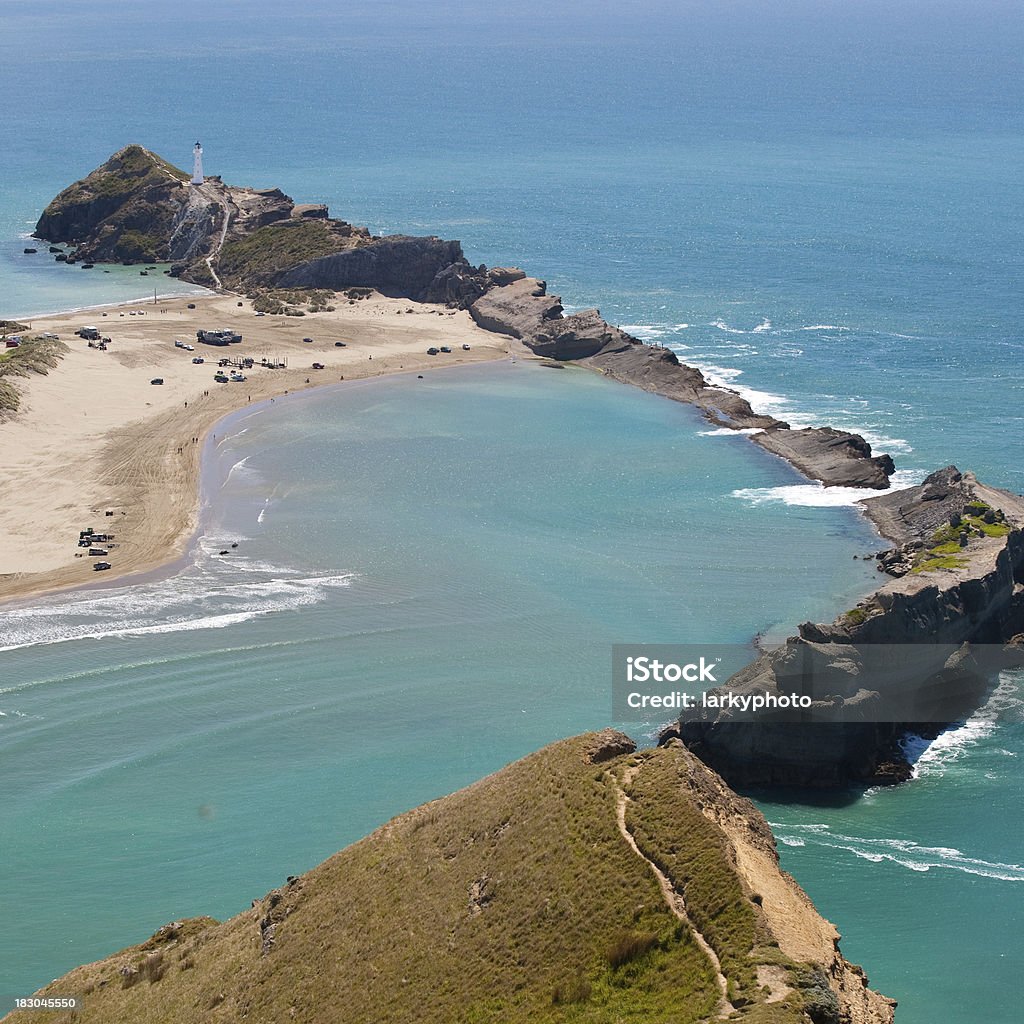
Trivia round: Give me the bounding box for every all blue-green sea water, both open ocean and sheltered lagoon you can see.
[0,0,1024,1024]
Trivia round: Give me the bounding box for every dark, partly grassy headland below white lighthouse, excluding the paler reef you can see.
[35,145,464,305]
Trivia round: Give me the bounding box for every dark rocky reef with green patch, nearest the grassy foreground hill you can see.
[663,466,1024,788]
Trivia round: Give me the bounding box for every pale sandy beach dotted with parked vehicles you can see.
[0,295,518,600]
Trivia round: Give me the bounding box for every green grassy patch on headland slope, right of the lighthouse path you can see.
[217,220,353,288]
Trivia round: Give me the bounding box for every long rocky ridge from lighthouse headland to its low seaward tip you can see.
[35,145,894,489]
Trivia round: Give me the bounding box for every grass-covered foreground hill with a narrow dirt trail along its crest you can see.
[7,732,892,1024]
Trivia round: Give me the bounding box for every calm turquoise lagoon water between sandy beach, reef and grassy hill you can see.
[0,362,873,990]
